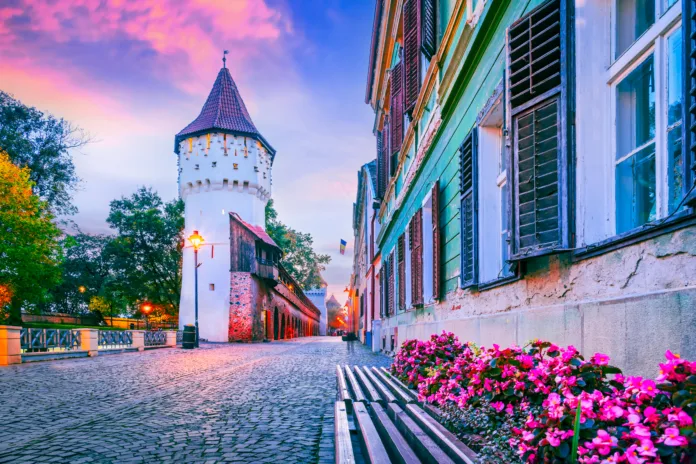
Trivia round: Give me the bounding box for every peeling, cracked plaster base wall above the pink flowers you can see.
[381,227,696,376]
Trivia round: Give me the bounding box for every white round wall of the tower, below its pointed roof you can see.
[179,133,271,342]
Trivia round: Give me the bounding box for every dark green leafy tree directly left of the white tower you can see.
[106,187,184,314]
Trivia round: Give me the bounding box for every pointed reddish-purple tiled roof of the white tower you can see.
[175,67,275,156]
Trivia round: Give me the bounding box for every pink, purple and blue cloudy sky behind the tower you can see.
[0,0,375,301]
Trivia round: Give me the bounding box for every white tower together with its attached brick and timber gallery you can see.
[174,63,320,342]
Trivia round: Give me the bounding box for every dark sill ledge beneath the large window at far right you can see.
[572,209,696,262]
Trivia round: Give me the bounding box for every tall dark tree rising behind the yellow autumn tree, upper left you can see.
[0,91,89,214]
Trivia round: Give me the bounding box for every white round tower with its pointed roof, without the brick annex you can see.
[174,59,275,342]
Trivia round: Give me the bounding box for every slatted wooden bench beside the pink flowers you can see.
[335,366,478,464]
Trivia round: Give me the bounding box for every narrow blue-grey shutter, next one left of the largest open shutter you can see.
[459,128,478,288]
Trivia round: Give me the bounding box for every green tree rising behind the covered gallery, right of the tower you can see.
[266,200,331,289]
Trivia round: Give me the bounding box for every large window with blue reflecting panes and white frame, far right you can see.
[609,0,687,234]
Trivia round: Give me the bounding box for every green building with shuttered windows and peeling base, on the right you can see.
[366,0,696,375]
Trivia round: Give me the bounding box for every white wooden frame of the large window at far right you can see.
[605,0,682,235]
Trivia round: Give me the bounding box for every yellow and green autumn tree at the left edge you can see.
[0,152,61,325]
